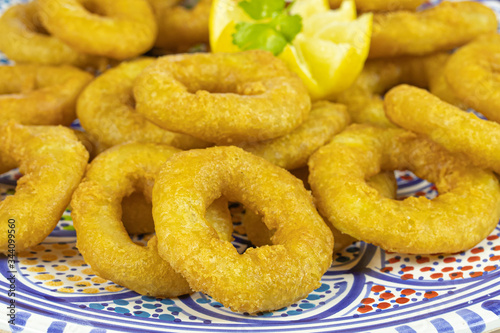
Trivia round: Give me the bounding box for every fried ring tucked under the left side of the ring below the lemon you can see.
[77,58,208,151]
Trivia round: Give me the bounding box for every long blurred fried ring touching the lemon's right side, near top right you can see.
[368,1,498,58]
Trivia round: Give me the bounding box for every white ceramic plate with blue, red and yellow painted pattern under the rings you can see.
[0,0,500,333]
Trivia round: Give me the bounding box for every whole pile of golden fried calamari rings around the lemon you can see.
[0,0,500,313]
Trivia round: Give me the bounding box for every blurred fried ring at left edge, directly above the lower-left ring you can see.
[0,65,93,126]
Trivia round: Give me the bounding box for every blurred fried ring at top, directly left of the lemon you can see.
[149,0,212,52]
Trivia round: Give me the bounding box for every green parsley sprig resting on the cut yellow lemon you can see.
[233,0,302,55]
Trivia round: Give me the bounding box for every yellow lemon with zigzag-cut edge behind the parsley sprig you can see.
[209,0,373,100]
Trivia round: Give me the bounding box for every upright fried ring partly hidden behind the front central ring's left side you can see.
[71,143,232,297]
